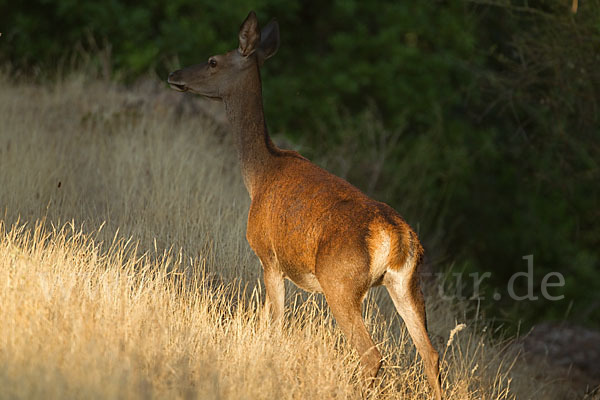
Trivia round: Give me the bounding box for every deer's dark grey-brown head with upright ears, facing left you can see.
[167,11,279,99]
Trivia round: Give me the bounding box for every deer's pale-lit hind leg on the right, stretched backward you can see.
[383,265,442,400]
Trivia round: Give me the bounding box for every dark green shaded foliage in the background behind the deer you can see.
[0,0,600,330]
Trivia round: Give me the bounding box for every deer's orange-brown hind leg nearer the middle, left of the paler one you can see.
[319,272,381,385]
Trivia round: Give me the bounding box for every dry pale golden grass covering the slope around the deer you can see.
[0,70,561,399]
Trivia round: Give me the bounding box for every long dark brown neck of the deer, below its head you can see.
[223,67,278,198]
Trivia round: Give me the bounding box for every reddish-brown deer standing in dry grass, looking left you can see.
[167,11,442,400]
